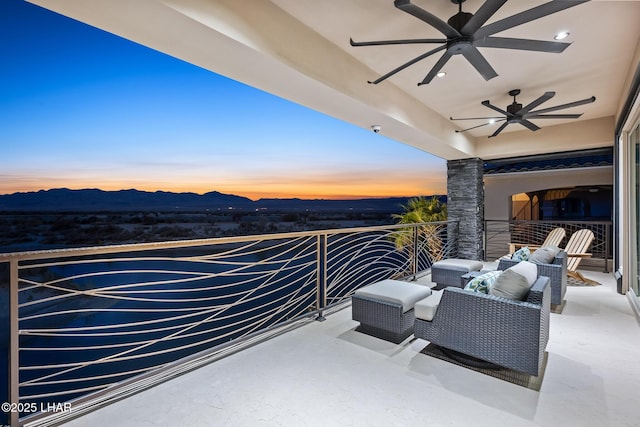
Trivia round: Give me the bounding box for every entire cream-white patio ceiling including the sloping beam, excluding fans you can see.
[33,0,640,159]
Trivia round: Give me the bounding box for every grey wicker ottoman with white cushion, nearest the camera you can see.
[351,280,431,344]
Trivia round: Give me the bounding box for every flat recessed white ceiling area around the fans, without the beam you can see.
[282,0,640,129]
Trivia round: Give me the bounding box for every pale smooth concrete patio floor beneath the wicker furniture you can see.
[60,271,640,427]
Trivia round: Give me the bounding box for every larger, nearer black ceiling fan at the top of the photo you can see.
[349,0,589,86]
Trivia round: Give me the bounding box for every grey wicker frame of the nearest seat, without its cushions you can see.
[414,276,551,376]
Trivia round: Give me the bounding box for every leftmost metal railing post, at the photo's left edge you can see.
[9,259,20,427]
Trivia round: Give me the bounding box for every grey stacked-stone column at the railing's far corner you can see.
[447,158,484,260]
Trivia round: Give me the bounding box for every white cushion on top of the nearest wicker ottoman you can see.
[355,279,431,313]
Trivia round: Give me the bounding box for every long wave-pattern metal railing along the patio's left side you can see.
[0,222,457,425]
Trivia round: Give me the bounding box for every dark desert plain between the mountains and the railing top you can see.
[0,210,394,253]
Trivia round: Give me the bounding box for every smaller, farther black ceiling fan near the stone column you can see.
[449,89,596,138]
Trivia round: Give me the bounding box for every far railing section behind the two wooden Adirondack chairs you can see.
[485,220,613,271]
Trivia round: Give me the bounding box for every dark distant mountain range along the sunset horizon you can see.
[0,188,446,212]
